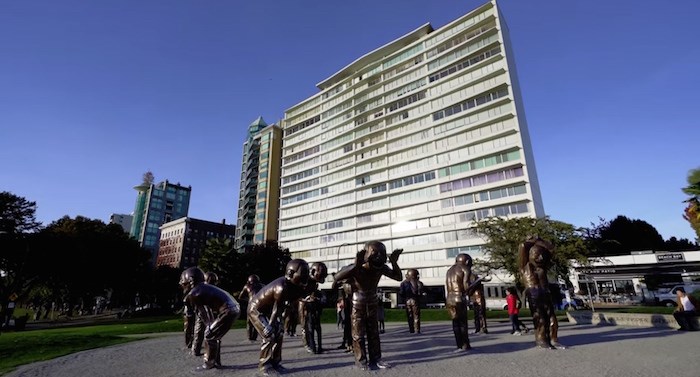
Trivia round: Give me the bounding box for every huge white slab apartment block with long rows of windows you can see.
[279,1,544,290]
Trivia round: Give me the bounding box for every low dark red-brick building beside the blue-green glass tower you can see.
[156,217,236,269]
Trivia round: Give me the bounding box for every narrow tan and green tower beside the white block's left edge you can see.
[235,117,282,252]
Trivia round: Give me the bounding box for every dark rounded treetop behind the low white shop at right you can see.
[587,215,666,256]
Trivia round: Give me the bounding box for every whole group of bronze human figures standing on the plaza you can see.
[180,237,564,376]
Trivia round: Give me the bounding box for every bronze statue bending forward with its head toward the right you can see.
[248,259,309,376]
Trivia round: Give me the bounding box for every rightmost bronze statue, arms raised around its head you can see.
[519,236,565,349]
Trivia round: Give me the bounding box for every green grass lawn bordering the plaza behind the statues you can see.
[0,307,673,375]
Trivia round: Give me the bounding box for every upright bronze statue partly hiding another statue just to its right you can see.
[445,254,476,351]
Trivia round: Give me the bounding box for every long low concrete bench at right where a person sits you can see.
[566,310,700,329]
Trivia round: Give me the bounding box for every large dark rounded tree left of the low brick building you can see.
[32,216,149,307]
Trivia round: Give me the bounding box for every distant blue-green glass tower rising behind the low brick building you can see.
[130,180,192,265]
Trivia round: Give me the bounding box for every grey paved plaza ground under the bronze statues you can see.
[8,322,700,377]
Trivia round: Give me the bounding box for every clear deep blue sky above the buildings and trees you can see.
[0,0,700,240]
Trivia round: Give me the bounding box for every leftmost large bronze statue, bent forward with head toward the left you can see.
[180,267,241,370]
